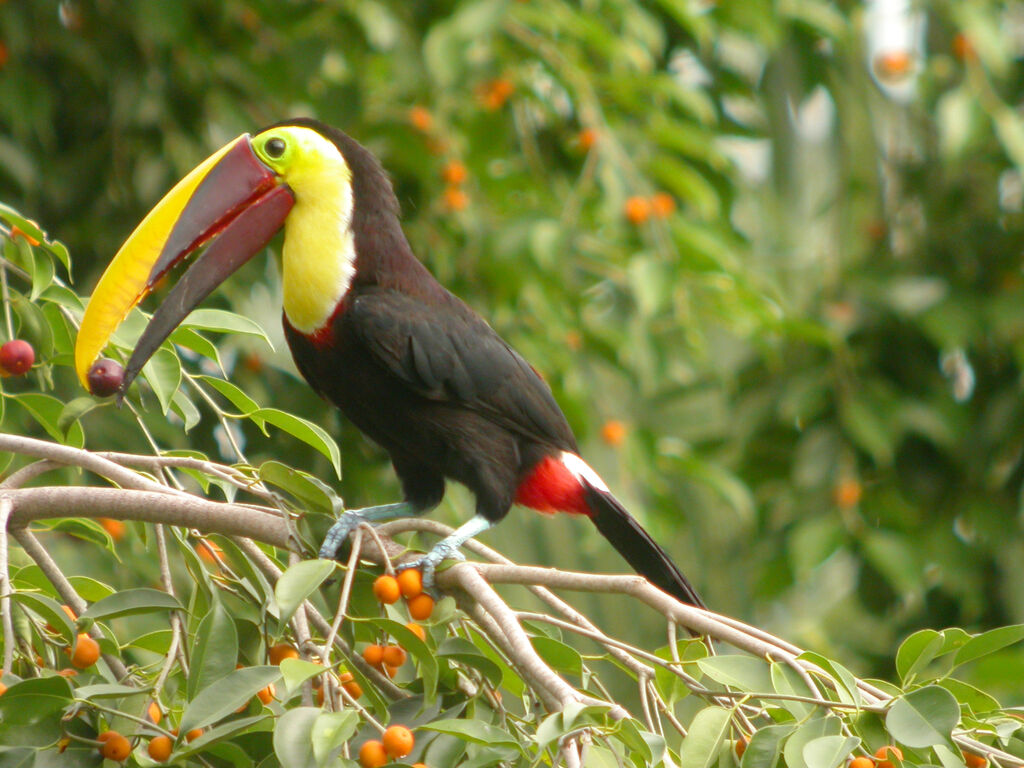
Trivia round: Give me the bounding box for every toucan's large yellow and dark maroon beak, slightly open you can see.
[75,134,295,394]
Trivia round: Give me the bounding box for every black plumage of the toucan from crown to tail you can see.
[276,120,702,605]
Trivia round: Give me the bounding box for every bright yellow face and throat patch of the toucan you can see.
[252,126,355,334]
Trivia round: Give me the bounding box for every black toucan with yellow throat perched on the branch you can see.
[75,118,703,606]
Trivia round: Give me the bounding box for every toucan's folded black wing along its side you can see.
[343,289,575,450]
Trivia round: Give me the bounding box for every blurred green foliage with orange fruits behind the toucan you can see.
[0,0,1024,696]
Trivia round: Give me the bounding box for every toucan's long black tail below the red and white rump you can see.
[583,480,706,608]
